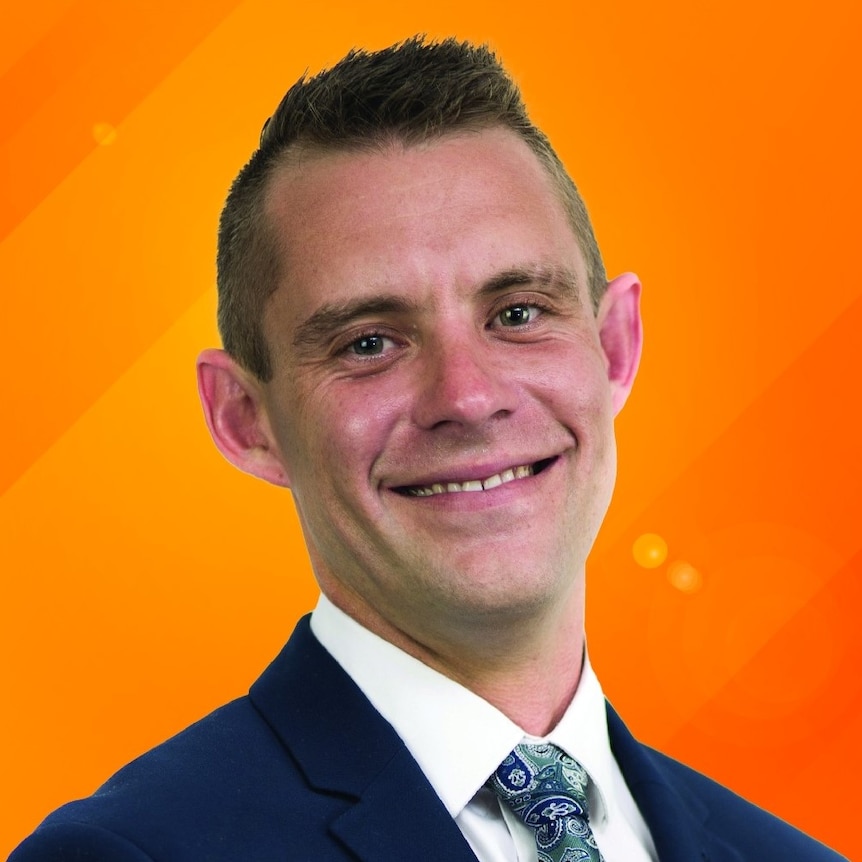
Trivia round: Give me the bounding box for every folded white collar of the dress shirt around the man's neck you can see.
[311,596,613,817]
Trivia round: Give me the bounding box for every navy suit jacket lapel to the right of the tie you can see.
[607,704,744,862]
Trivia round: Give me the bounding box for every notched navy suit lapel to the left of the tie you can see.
[250,617,476,862]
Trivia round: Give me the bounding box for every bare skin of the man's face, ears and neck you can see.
[198,129,641,734]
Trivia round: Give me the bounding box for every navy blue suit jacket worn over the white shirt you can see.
[10,617,846,862]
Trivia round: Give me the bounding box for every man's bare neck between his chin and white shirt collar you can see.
[324,579,584,736]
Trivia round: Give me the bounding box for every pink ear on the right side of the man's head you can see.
[596,272,643,415]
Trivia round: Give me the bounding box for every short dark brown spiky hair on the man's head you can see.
[218,36,606,381]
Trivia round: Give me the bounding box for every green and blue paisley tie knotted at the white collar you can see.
[487,743,603,862]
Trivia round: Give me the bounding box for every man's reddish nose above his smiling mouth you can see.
[414,338,517,429]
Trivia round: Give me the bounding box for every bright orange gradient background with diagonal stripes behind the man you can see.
[0,0,862,858]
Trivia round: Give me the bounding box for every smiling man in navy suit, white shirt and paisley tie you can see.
[12,33,852,862]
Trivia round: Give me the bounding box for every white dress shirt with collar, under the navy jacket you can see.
[311,596,658,862]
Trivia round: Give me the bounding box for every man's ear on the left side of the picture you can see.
[197,350,289,487]
